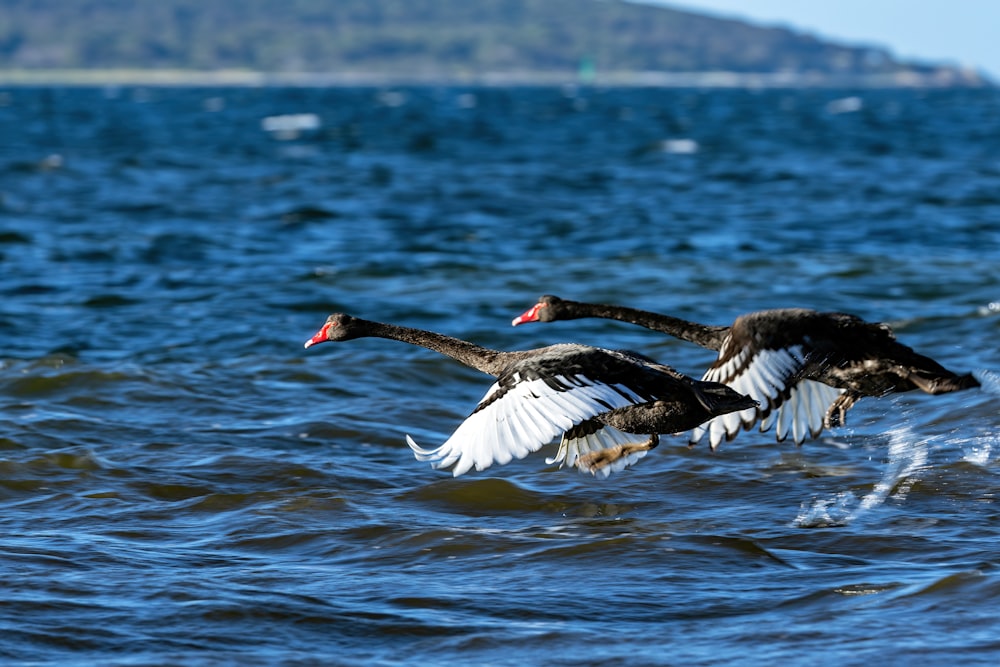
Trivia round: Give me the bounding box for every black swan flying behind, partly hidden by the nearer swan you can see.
[512,295,979,449]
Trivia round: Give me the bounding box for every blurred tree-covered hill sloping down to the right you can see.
[0,0,975,82]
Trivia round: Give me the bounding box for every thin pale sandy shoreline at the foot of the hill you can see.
[0,67,995,88]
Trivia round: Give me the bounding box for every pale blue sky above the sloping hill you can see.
[641,0,1000,81]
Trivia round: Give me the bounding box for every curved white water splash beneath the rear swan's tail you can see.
[792,426,931,528]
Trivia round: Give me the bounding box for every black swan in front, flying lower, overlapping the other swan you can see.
[305,313,757,477]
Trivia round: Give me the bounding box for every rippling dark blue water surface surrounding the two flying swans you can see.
[0,88,1000,667]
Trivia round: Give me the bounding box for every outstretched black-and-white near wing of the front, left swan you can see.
[407,346,659,477]
